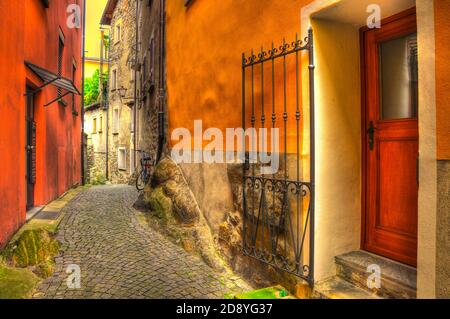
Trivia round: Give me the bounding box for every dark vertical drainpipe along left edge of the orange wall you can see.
[156,0,166,162]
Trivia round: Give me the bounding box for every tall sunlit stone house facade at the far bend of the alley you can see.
[101,0,136,184]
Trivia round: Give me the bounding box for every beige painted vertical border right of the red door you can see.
[417,0,437,298]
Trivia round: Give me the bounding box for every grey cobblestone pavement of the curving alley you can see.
[35,186,249,299]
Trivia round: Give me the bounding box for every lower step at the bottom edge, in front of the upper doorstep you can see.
[312,277,380,299]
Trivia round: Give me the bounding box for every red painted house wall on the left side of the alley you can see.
[0,0,82,247]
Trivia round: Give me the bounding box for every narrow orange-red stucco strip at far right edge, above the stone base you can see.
[435,0,450,160]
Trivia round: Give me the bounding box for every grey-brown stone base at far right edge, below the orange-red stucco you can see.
[436,161,450,298]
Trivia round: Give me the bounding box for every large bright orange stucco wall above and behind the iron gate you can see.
[166,0,310,153]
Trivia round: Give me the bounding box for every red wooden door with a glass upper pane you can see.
[362,10,418,266]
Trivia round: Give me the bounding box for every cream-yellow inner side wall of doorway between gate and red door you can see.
[312,19,361,280]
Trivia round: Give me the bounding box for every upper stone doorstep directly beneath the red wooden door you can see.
[335,251,417,299]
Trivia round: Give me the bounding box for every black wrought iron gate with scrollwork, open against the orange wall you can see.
[242,29,315,285]
